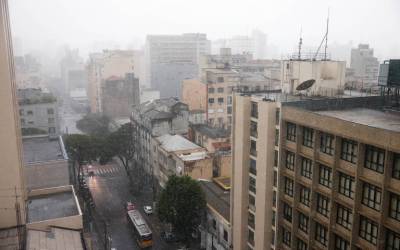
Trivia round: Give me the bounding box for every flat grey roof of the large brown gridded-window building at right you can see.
[315,108,400,132]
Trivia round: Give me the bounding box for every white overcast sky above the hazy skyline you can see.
[9,0,400,57]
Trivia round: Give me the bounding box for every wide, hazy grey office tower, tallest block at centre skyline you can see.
[145,34,210,98]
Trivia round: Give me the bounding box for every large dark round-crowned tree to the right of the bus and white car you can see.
[157,175,206,243]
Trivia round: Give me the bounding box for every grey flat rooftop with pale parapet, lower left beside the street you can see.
[27,191,79,223]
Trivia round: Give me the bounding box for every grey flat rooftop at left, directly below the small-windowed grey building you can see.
[22,136,68,164]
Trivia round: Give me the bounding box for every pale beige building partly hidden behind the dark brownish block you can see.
[86,50,135,113]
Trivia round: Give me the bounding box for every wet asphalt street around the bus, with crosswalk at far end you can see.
[87,163,183,250]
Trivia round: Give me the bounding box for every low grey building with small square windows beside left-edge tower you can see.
[17,88,60,136]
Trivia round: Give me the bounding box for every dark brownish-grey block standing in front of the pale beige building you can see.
[101,73,140,118]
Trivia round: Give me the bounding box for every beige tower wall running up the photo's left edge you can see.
[0,0,26,228]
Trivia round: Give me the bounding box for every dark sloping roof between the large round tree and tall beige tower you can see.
[199,180,230,221]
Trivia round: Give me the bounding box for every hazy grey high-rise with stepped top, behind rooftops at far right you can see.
[350,44,379,89]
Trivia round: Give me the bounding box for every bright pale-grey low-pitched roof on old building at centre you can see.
[157,134,202,152]
